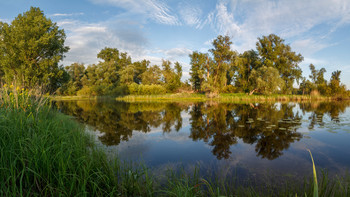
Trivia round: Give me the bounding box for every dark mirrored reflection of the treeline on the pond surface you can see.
[56,101,348,160]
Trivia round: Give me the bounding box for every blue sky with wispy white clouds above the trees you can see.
[0,0,350,89]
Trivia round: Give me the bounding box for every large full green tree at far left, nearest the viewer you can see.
[0,7,69,92]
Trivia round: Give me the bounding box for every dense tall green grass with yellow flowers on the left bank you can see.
[0,87,153,196]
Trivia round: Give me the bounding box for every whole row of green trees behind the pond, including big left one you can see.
[0,7,349,96]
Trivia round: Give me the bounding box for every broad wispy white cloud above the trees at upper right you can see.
[207,0,350,53]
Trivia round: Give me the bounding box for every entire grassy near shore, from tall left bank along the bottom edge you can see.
[0,88,350,196]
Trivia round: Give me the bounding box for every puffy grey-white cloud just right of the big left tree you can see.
[58,20,148,65]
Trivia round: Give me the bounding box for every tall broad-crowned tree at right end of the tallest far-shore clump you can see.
[256,34,303,93]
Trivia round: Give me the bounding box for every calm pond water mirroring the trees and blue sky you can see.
[56,101,350,185]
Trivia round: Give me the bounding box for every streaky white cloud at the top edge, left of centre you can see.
[91,0,180,25]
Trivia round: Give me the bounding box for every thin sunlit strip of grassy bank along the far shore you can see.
[116,93,337,102]
